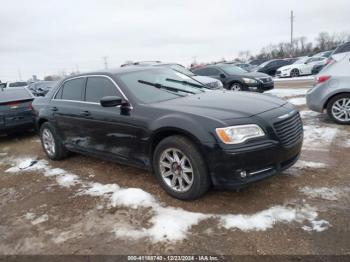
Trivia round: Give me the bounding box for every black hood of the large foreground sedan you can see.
[153,90,286,121]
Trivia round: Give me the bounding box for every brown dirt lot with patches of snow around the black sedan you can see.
[0,81,350,255]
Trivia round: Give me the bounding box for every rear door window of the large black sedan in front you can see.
[56,77,86,101]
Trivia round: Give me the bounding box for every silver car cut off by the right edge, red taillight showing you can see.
[306,42,350,125]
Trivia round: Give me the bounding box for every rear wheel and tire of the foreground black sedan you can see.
[40,122,68,160]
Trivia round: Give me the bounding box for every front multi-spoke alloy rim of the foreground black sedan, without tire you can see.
[159,148,194,193]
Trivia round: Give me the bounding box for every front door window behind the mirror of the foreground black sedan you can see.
[85,76,122,103]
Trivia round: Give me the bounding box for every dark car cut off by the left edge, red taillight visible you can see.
[0,87,34,134]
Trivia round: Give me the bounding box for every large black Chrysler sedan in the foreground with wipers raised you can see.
[33,67,303,200]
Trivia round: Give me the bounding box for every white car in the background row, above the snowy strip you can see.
[276,56,327,77]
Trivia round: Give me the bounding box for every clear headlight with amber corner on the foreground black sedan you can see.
[215,124,265,144]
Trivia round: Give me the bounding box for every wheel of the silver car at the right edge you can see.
[327,94,350,125]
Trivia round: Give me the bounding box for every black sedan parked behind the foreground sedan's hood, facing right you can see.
[192,64,274,93]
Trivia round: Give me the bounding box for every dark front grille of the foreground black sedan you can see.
[274,113,303,147]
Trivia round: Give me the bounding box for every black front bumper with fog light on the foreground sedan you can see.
[204,138,302,189]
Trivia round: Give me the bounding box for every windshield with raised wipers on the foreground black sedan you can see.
[117,68,205,104]
